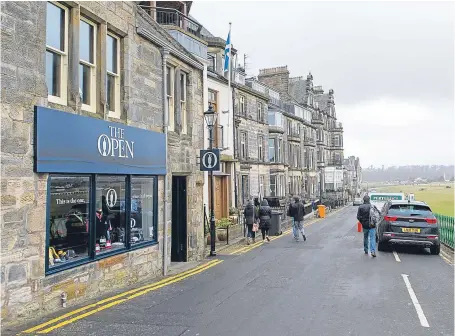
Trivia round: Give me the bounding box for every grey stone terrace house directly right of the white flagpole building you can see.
[232,68,270,206]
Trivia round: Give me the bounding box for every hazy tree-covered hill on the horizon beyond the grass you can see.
[362,165,454,182]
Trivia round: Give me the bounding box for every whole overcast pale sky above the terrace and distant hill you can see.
[190,1,455,167]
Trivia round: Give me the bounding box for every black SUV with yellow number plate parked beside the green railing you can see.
[377,201,441,255]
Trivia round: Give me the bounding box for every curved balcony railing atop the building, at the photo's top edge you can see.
[140,5,202,37]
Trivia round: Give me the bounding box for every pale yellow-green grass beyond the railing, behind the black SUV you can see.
[376,183,454,217]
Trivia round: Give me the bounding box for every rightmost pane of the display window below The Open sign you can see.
[130,177,156,244]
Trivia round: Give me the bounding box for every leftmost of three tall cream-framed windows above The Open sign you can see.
[46,2,69,105]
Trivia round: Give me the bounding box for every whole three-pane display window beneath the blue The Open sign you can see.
[46,174,158,273]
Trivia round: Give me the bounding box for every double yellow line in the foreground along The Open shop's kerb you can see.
[21,259,223,334]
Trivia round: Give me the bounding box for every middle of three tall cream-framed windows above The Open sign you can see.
[79,18,96,112]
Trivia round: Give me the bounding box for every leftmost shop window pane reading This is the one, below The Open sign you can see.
[48,176,91,268]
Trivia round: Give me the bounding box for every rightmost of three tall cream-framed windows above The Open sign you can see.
[106,33,121,118]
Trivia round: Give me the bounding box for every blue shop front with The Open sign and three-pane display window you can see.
[35,107,166,276]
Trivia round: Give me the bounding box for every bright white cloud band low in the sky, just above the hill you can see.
[337,99,455,167]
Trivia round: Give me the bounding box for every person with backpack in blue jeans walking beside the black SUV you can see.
[357,195,379,257]
